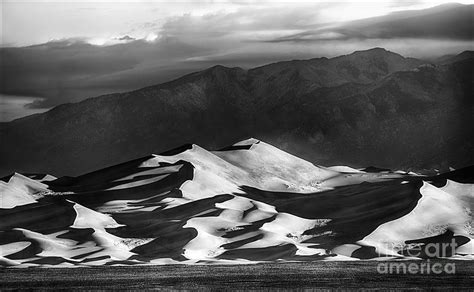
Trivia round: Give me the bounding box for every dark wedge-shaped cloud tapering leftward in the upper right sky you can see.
[270,4,474,42]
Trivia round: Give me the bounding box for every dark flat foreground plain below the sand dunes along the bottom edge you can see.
[0,261,474,291]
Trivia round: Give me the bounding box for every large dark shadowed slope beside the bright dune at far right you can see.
[241,180,422,250]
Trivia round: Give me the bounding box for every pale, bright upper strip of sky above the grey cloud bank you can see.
[1,0,474,46]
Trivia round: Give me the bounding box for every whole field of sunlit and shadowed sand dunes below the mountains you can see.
[0,139,474,267]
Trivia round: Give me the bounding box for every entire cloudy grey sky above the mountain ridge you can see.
[0,0,474,121]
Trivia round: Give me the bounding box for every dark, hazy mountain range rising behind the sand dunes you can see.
[0,48,474,175]
